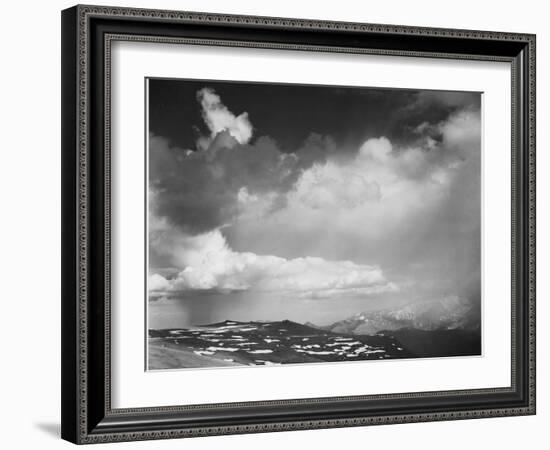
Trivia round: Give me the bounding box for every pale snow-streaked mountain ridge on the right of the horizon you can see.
[322,296,481,335]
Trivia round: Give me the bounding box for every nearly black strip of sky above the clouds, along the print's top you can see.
[149,79,479,153]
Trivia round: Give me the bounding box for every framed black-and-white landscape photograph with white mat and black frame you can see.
[62,6,535,444]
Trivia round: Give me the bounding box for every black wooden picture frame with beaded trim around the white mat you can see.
[62,6,535,444]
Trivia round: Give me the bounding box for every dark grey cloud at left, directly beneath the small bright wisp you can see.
[149,131,333,234]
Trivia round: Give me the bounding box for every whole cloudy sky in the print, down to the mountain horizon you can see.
[148,79,481,328]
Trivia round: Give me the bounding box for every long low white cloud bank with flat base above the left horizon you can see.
[149,230,397,298]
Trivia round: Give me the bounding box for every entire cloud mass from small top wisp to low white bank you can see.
[149,88,481,312]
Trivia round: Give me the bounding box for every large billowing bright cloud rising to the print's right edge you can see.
[283,111,480,222]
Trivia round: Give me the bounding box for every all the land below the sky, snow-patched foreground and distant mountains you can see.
[148,297,481,370]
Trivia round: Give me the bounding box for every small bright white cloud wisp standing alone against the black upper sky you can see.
[197,88,253,146]
